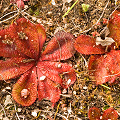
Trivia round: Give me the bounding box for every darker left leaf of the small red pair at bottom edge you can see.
[88,107,100,120]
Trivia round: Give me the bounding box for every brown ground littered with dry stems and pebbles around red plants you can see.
[0,0,120,120]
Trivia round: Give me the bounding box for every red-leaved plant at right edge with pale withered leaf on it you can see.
[74,10,120,84]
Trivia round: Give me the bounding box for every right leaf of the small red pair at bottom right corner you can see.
[102,107,118,120]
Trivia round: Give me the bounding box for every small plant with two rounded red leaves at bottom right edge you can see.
[88,107,118,120]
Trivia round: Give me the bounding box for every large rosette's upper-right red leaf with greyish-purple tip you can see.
[41,31,75,61]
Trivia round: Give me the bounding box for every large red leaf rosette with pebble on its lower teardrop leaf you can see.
[0,18,76,106]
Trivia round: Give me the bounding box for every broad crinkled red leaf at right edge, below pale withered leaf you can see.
[89,50,120,84]
